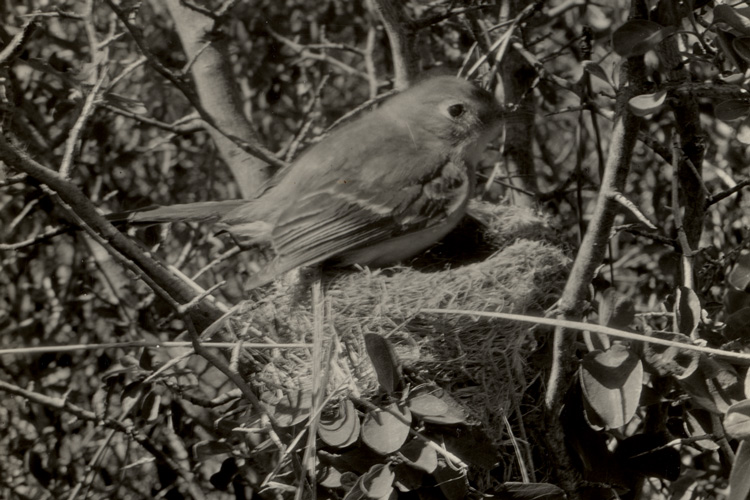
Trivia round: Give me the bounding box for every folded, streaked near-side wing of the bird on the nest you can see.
[244,161,472,286]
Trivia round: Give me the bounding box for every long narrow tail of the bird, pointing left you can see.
[107,200,247,225]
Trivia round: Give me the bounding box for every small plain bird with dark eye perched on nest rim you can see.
[120,76,503,288]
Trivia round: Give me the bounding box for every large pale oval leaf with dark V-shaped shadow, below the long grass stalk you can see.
[580,344,643,428]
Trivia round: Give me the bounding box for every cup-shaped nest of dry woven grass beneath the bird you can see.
[238,205,570,450]
